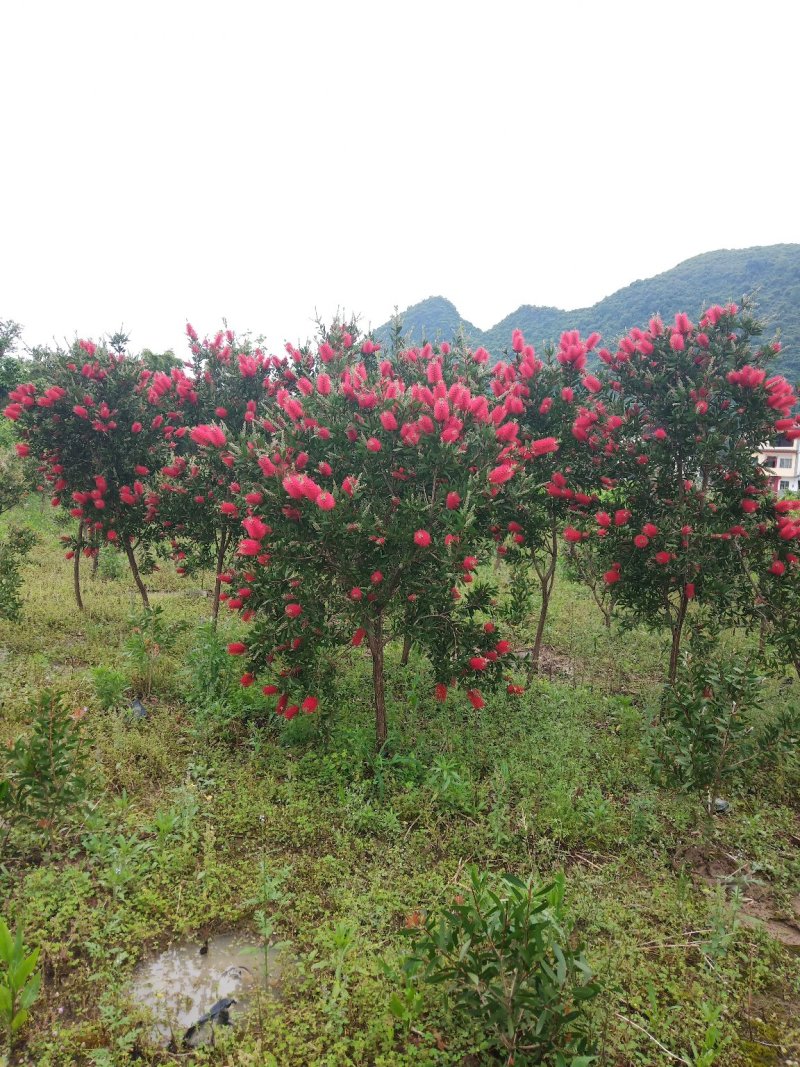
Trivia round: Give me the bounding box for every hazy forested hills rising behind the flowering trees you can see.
[377,244,800,381]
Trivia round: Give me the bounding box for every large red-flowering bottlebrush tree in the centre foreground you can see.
[222,324,541,744]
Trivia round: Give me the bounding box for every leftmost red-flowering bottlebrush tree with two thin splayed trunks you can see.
[3,340,172,607]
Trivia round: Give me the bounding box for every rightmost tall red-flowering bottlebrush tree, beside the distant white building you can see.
[564,304,800,682]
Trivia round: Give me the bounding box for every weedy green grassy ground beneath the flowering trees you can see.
[0,504,800,1067]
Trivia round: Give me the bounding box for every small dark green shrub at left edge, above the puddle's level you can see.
[0,690,86,845]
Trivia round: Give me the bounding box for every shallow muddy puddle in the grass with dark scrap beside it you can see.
[130,933,281,1049]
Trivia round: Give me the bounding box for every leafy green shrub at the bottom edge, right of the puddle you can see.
[405,867,599,1067]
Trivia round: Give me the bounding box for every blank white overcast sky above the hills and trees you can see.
[0,0,800,352]
